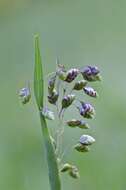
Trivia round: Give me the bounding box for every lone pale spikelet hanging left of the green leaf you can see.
[19,87,31,104]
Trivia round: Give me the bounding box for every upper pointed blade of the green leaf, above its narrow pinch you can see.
[34,35,44,110]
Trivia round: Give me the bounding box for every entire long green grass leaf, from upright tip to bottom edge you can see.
[34,36,61,190]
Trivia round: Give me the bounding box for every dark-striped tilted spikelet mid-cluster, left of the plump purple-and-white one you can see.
[62,94,75,109]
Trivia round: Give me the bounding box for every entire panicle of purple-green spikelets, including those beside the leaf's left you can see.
[19,64,101,178]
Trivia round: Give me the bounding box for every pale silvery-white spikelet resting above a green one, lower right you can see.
[79,135,95,146]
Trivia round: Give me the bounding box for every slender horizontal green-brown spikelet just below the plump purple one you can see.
[67,119,89,129]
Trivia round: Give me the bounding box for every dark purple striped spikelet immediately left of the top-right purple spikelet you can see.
[65,68,79,83]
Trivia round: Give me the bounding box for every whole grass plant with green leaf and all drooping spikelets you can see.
[19,36,101,190]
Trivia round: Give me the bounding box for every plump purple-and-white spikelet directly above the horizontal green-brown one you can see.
[79,102,95,119]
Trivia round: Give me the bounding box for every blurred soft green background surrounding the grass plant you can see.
[0,0,126,190]
